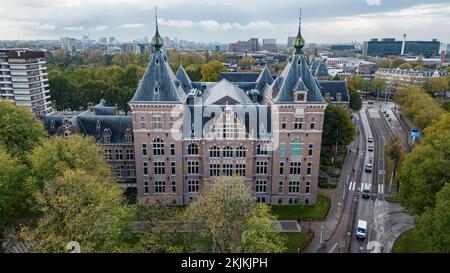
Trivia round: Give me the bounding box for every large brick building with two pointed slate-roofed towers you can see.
[129,12,327,204]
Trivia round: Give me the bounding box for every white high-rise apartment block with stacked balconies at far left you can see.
[0,49,52,116]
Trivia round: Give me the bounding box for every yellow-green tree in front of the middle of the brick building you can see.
[186,177,284,253]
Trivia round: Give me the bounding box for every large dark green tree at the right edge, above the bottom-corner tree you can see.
[397,113,450,215]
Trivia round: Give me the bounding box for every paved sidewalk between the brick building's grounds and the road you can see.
[303,136,358,253]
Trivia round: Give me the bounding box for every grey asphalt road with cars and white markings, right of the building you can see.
[350,103,413,253]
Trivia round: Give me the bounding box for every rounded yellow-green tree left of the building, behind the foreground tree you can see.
[30,134,111,190]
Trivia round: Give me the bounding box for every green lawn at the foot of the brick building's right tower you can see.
[271,195,330,221]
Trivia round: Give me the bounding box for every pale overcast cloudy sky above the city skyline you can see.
[0,0,450,43]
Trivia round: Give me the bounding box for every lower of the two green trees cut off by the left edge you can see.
[0,146,29,240]
